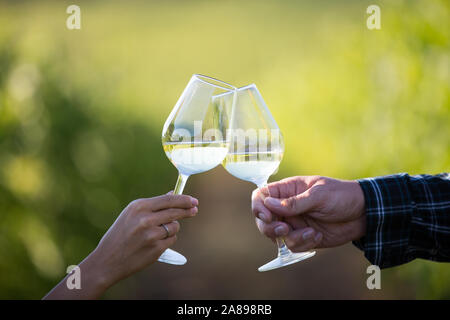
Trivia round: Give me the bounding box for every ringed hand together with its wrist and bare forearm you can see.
[44,194,198,299]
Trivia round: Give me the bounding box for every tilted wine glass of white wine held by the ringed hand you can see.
[158,74,236,265]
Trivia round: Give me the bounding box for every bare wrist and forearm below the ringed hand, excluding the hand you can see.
[43,251,113,300]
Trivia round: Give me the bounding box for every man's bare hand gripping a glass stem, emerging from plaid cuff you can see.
[252,176,366,252]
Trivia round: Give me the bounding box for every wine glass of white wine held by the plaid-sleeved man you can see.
[222,84,315,272]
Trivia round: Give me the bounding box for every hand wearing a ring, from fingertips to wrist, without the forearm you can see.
[93,194,198,283]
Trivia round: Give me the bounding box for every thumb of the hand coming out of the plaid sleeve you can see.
[264,191,317,217]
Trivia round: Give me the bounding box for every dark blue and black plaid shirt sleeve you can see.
[353,173,450,268]
